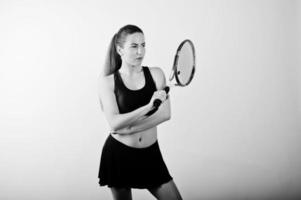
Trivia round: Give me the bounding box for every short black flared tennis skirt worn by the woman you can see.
[98,135,172,189]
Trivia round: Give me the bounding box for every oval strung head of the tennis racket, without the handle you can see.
[169,39,195,86]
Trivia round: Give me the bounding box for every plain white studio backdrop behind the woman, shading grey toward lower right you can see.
[0,0,301,200]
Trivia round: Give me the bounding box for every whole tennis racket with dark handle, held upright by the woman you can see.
[146,39,195,116]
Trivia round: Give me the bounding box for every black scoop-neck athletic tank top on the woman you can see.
[114,67,157,113]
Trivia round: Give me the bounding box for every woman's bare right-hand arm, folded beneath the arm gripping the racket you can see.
[114,68,170,134]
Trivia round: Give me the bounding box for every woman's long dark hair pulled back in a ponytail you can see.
[103,24,143,76]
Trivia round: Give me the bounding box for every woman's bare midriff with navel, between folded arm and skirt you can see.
[111,127,157,148]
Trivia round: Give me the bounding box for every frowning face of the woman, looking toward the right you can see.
[117,33,145,66]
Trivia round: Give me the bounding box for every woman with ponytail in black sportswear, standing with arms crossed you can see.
[98,25,182,200]
